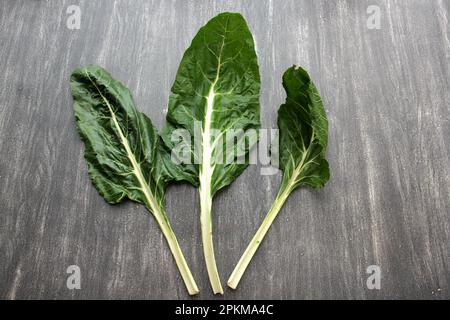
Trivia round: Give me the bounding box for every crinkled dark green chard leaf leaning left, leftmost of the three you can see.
[70,66,198,294]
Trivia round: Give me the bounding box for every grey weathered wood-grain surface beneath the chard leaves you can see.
[0,0,450,299]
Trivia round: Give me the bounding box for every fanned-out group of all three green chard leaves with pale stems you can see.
[71,13,330,294]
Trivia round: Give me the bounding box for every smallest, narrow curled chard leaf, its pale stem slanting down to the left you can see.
[228,67,330,289]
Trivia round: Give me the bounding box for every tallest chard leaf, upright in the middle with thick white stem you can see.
[163,13,260,293]
